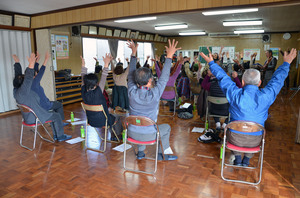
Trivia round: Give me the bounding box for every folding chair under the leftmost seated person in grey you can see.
[17,104,55,151]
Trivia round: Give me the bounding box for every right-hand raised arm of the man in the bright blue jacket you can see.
[262,48,297,100]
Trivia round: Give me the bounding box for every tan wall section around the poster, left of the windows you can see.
[50,26,82,75]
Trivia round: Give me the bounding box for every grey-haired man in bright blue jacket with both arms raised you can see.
[200,49,297,166]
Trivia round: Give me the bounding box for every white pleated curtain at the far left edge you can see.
[0,29,31,113]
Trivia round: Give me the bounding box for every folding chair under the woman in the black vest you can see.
[81,102,120,152]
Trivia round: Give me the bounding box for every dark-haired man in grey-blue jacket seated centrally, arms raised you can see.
[127,40,181,160]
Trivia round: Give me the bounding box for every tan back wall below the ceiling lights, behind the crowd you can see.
[175,33,300,85]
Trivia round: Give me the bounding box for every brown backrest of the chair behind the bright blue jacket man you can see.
[226,120,265,135]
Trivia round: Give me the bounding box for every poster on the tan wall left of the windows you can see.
[55,35,69,59]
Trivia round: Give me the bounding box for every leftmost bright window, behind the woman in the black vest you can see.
[82,38,110,73]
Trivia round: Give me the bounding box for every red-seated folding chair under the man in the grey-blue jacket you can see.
[123,116,165,175]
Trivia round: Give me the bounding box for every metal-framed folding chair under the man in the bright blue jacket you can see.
[221,121,266,185]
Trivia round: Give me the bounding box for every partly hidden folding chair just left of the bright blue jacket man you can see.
[205,96,230,129]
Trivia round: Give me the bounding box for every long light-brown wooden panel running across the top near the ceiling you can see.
[31,0,292,28]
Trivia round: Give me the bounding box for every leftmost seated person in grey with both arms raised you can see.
[13,53,72,142]
